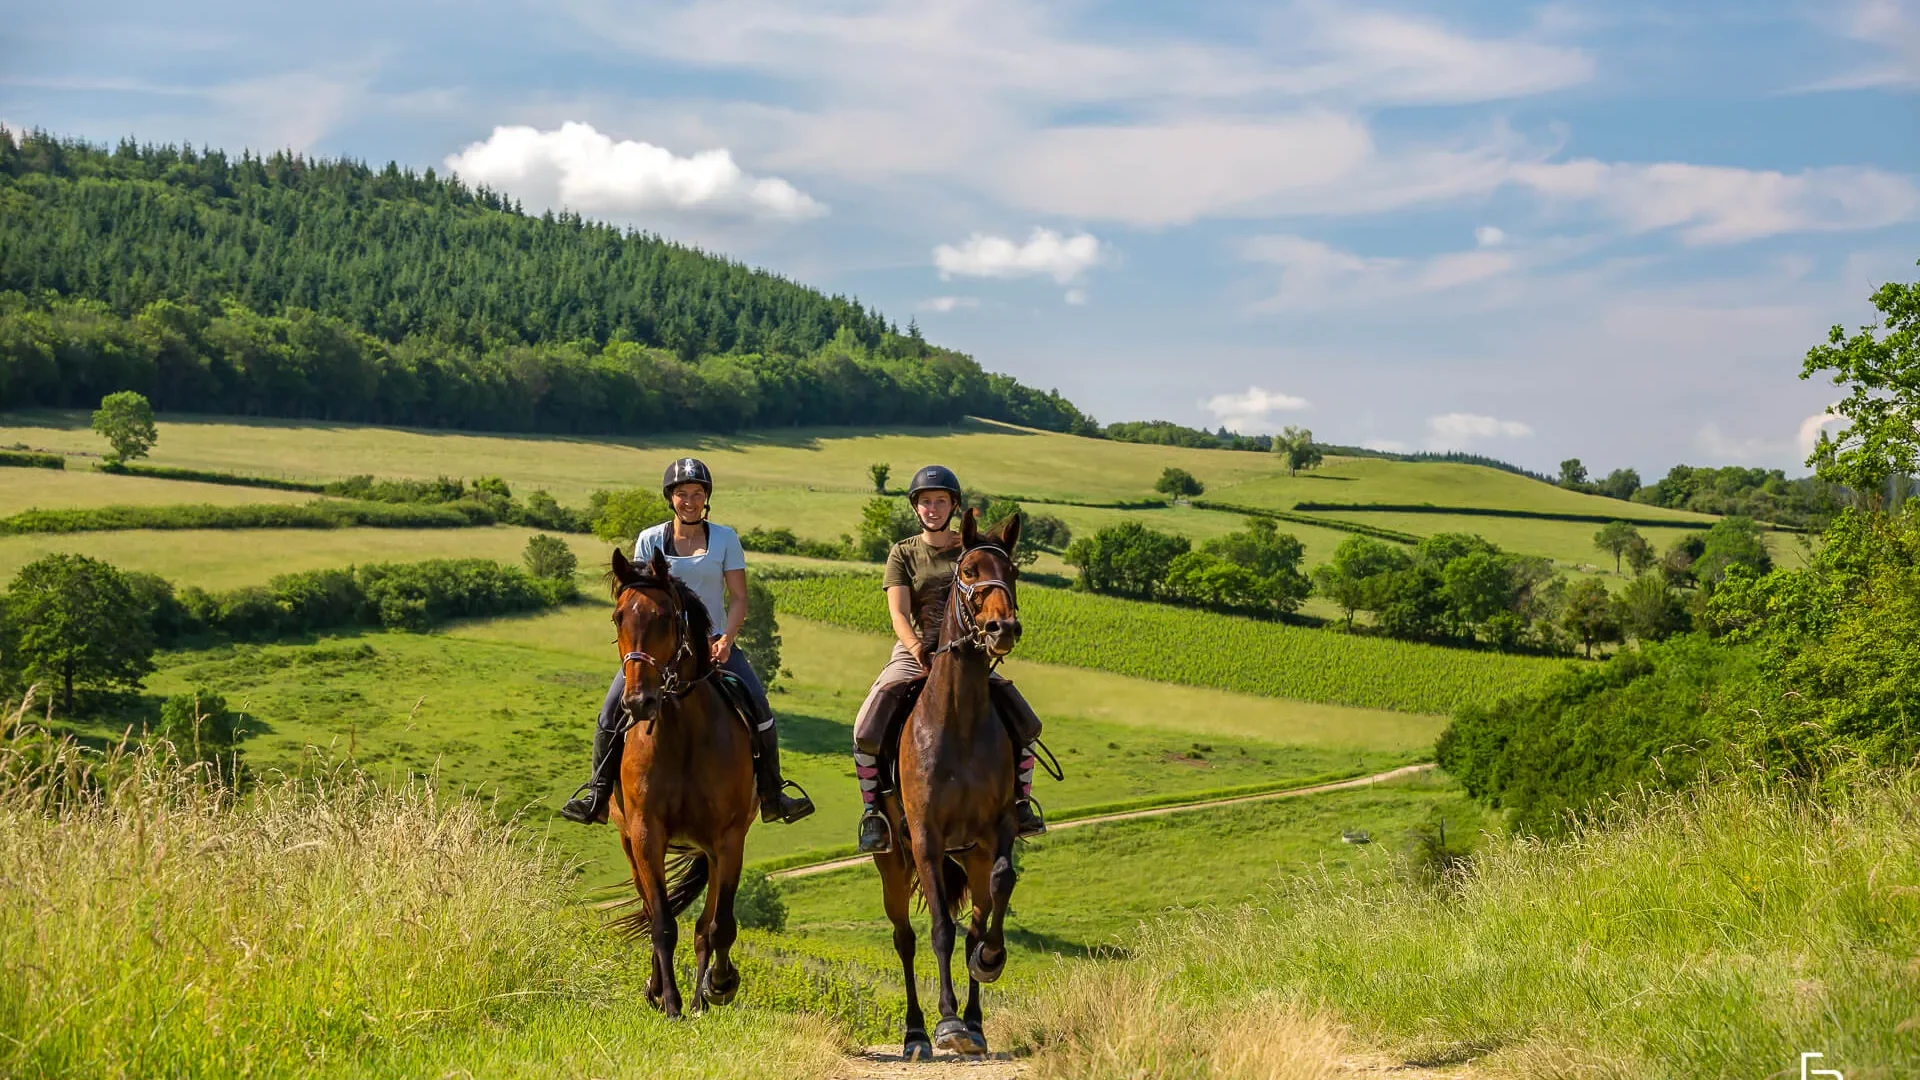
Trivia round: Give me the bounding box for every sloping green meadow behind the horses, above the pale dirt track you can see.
[120,603,1444,880]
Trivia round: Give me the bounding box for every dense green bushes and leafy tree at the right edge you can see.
[1438,261,1920,836]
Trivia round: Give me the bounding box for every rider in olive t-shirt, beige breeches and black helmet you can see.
[852,465,1046,855]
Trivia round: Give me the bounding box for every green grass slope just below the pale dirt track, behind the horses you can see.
[781,776,1492,953]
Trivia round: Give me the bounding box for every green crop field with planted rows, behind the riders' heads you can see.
[772,575,1569,713]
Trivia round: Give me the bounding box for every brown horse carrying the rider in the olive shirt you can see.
[874,509,1020,1059]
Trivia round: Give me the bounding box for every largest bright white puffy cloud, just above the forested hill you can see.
[445,123,828,221]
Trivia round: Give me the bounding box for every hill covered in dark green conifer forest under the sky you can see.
[0,129,1096,432]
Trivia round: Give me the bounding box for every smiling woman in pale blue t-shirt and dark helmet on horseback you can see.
[561,457,814,824]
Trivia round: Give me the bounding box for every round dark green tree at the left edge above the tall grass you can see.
[0,555,154,715]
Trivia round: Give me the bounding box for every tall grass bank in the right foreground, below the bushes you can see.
[1000,774,1920,1080]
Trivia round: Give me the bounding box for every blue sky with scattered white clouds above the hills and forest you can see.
[0,0,1920,470]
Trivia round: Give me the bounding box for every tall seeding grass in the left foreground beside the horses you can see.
[0,687,845,1078]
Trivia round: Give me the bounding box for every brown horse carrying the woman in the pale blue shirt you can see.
[609,550,758,1019]
